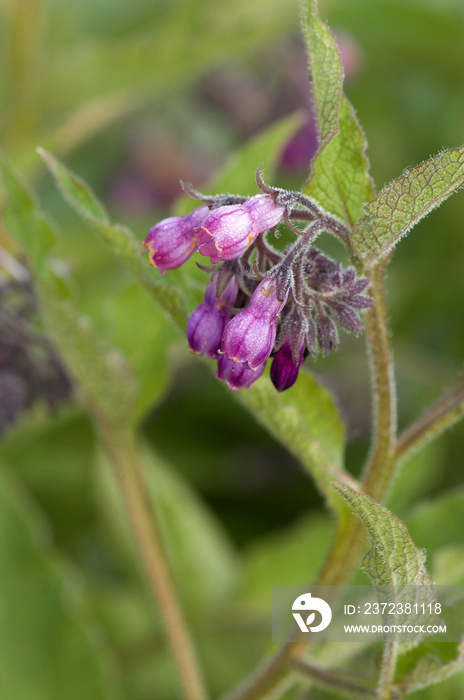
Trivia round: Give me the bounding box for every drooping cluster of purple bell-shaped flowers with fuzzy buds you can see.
[143,170,371,391]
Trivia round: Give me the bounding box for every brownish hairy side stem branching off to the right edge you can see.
[396,377,464,462]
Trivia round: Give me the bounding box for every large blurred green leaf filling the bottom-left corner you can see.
[0,467,119,700]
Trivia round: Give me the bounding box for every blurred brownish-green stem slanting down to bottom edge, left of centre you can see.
[99,421,206,700]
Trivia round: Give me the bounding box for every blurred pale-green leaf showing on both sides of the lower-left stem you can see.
[99,447,238,615]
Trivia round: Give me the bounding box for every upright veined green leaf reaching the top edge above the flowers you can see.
[303,0,374,225]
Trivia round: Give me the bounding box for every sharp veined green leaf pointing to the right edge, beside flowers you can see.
[352,146,464,265]
